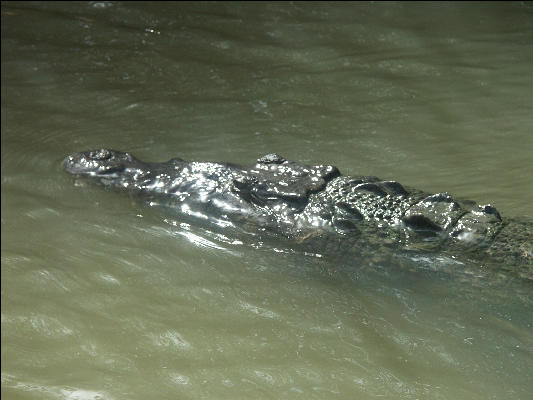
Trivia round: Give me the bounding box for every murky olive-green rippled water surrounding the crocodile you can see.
[1,2,533,400]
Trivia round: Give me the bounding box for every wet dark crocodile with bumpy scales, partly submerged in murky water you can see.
[62,149,533,281]
